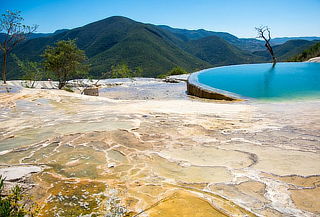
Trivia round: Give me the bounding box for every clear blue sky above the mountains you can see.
[0,0,320,37]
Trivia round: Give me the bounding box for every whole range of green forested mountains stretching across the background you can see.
[0,16,315,79]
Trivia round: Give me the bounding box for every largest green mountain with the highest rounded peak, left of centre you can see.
[8,17,211,78]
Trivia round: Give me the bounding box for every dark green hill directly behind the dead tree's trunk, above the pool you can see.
[253,40,316,61]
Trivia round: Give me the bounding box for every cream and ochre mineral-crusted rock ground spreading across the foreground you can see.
[0,80,320,217]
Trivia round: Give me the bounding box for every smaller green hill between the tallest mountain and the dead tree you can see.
[185,36,260,66]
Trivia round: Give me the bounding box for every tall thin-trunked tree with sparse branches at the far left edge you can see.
[0,10,38,84]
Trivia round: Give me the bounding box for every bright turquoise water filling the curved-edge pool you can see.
[189,63,320,100]
